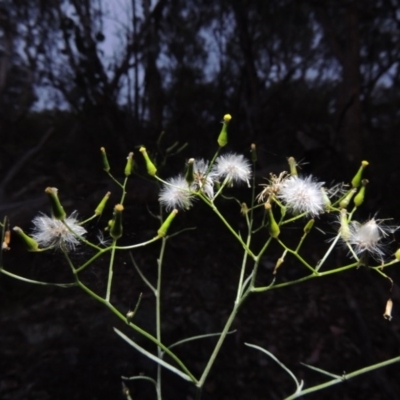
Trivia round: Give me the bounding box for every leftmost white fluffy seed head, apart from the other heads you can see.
[32,211,87,251]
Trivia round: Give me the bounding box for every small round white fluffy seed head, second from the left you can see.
[159,175,193,211]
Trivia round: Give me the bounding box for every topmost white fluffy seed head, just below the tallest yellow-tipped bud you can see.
[212,154,251,187]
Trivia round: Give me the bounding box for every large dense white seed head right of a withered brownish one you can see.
[277,175,325,217]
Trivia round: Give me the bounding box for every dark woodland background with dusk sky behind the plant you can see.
[0,0,400,400]
